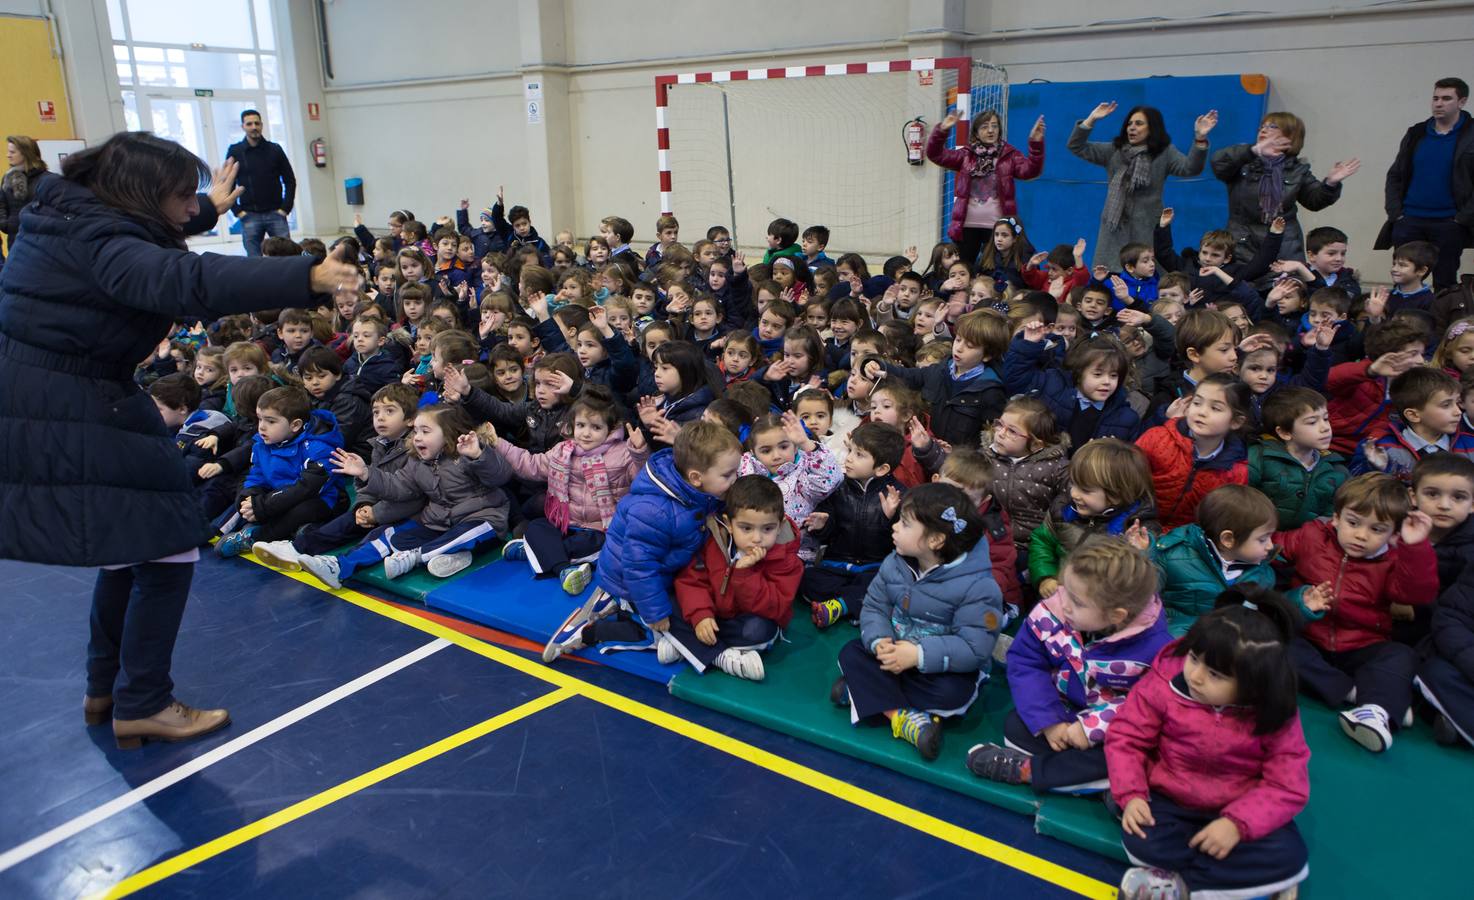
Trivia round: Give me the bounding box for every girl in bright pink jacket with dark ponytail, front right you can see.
[1106,586,1310,900]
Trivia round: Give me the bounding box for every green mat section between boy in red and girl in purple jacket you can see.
[671,608,1039,816]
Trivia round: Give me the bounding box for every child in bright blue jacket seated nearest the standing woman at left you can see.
[215,387,346,557]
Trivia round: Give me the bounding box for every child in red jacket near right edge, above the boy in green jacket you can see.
[1325,318,1428,455]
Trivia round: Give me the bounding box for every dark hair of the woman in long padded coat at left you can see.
[62,131,209,249]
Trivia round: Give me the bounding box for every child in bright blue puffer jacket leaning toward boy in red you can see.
[542,421,741,663]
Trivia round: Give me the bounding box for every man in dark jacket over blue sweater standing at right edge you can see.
[1374,78,1474,290]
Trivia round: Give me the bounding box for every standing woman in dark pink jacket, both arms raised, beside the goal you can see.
[926,109,1044,271]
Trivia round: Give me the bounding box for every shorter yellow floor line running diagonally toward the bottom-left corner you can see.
[102,688,578,899]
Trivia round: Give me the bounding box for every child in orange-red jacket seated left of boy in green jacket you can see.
[1136,373,1253,530]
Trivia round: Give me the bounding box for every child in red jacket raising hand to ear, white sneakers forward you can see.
[1275,473,1439,753]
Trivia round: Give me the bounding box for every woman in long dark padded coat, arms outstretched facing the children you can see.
[0,133,358,748]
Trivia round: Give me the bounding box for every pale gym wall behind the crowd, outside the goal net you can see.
[281,0,1474,277]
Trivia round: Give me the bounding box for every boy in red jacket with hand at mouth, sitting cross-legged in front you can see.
[669,474,803,681]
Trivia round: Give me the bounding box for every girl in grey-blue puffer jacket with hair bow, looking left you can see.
[830,483,1004,760]
